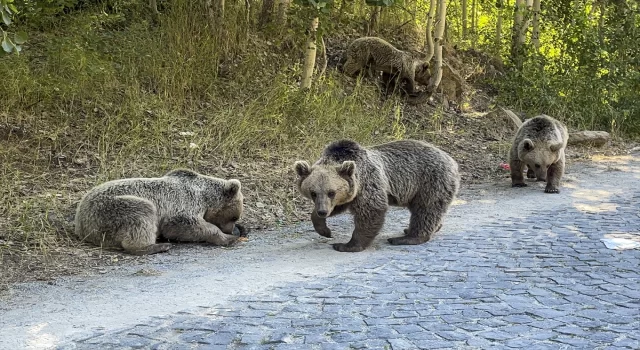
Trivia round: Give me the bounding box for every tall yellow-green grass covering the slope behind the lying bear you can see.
[0,1,404,255]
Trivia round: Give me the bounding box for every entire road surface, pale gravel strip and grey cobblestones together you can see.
[0,155,640,350]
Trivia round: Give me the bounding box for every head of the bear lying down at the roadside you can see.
[204,179,244,234]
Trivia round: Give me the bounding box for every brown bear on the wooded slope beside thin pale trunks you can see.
[342,37,430,94]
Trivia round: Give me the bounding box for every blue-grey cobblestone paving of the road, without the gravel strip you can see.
[58,190,640,350]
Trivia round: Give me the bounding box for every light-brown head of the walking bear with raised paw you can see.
[294,160,358,218]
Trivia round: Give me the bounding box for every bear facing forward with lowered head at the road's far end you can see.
[509,114,569,193]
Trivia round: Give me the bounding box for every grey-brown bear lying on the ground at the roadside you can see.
[75,169,244,255]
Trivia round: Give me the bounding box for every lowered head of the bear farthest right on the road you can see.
[518,139,562,181]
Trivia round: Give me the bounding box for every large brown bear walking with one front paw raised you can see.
[295,140,460,252]
